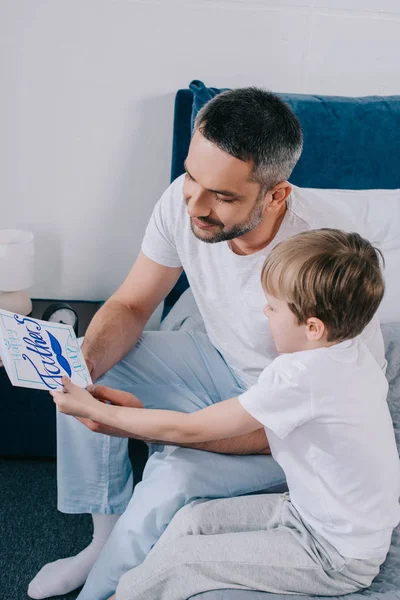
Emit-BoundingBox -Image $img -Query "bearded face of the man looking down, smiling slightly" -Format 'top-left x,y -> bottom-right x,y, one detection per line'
183,131 -> 265,243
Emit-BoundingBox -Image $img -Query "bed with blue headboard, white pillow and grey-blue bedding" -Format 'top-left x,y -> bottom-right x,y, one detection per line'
161,81 -> 400,600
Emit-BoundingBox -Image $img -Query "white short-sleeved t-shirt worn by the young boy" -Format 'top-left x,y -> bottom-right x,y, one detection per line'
239,337 -> 400,559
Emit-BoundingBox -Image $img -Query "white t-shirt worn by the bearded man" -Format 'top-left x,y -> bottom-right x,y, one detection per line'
142,175 -> 386,386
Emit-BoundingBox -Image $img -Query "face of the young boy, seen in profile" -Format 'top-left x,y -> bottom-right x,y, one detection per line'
264,294 -> 308,354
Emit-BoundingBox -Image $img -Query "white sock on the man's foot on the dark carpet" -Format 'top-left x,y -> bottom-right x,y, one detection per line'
28,514 -> 121,600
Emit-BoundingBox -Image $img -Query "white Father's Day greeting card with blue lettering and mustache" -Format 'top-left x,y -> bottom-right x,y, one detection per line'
0,310 -> 92,391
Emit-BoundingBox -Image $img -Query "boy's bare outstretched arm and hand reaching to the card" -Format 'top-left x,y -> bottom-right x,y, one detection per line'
52,380 -> 261,444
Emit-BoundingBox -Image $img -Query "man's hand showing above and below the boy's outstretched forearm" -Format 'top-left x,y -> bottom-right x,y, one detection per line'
75,385 -> 147,441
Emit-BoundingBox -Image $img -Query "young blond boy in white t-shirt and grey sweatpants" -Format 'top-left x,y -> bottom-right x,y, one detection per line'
52,229 -> 400,600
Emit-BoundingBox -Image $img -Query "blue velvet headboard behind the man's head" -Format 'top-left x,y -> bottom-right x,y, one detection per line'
165,81 -> 400,312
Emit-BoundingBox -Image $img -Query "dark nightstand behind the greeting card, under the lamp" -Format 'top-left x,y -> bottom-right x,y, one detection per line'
0,300 -> 102,457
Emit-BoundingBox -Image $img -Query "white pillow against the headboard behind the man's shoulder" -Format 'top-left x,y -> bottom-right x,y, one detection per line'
302,188 -> 400,323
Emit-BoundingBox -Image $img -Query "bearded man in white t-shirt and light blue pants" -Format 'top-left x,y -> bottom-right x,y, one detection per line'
28,88 -> 384,600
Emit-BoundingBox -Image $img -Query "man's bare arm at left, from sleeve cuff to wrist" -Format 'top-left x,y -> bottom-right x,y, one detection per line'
82,252 -> 182,381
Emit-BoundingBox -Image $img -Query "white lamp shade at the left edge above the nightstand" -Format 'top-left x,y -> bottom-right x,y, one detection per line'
0,229 -> 35,292
